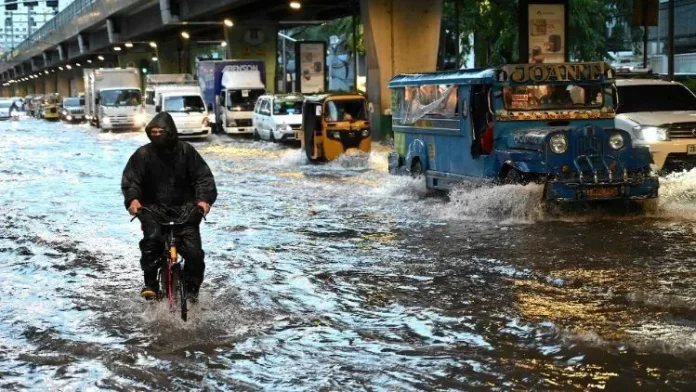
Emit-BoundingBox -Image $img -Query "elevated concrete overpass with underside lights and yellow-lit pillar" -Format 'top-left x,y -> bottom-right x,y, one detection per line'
0,0 -> 442,135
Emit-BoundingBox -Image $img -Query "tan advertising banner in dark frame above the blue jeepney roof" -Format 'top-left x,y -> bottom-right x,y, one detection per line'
527,4 -> 567,64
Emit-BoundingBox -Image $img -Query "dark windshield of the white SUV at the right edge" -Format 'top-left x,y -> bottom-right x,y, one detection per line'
617,84 -> 696,113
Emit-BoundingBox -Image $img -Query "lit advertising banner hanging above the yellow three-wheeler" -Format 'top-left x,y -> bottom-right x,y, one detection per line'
296,42 -> 326,94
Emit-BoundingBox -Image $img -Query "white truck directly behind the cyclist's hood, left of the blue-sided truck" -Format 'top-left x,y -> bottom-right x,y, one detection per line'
145,74 -> 210,139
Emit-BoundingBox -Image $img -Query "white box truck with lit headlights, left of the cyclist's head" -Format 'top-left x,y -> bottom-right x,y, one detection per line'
83,68 -> 146,130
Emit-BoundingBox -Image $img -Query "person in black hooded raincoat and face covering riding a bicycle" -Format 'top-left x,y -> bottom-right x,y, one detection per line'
121,112 -> 217,300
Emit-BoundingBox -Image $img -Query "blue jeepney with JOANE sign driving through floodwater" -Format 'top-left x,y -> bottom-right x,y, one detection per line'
389,63 -> 659,201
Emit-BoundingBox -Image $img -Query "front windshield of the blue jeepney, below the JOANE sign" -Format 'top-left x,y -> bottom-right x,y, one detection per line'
503,84 -> 604,110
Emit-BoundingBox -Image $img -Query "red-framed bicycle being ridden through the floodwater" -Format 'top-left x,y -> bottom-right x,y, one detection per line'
131,207 -> 205,321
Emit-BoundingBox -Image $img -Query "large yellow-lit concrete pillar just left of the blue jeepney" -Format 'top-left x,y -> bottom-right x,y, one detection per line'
360,0 -> 442,139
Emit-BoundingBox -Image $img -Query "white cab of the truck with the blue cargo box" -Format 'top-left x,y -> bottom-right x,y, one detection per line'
216,66 -> 266,134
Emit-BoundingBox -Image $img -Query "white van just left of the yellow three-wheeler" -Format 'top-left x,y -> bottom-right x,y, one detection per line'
252,94 -> 304,142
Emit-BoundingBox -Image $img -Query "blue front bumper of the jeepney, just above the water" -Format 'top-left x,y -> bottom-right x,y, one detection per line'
545,177 -> 659,201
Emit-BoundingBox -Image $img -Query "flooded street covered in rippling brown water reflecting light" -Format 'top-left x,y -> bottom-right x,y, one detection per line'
0,119 -> 696,391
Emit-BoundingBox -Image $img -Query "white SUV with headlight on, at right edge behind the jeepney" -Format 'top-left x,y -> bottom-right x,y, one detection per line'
616,79 -> 696,173
